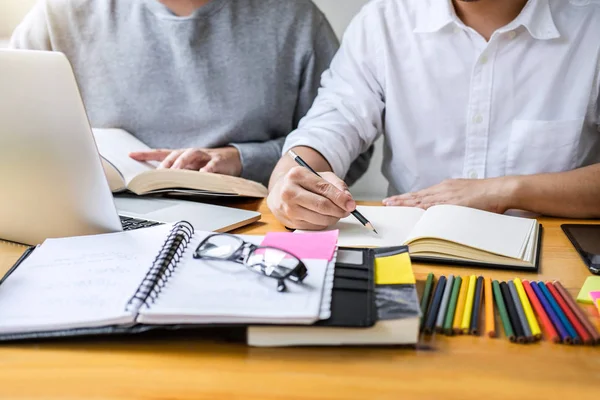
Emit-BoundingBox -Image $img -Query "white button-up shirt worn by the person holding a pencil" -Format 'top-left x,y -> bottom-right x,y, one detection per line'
284,0 -> 600,194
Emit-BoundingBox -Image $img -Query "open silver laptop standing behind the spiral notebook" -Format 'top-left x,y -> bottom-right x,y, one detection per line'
0,50 -> 260,244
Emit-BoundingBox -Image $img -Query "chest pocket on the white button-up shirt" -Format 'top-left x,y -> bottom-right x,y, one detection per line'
506,118 -> 584,175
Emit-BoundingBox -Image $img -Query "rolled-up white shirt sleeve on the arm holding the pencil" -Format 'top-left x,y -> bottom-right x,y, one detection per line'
283,7 -> 385,177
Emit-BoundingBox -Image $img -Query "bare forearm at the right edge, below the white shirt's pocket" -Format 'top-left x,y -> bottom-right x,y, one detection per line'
506,164 -> 600,218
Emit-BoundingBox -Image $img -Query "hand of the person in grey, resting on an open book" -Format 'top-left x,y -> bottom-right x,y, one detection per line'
129,146 -> 242,176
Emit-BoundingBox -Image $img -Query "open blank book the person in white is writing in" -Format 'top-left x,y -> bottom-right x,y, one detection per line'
310,205 -> 541,271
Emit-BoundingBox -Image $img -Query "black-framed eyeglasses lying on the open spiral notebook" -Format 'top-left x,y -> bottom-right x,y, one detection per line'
194,233 -> 308,292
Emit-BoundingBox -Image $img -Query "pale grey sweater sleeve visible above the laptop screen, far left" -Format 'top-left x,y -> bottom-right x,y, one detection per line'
10,1 -> 52,51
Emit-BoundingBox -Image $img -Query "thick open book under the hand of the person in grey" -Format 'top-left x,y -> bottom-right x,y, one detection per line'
93,129 -> 267,198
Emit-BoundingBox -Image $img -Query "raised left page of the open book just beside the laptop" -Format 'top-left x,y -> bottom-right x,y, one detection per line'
93,129 -> 157,185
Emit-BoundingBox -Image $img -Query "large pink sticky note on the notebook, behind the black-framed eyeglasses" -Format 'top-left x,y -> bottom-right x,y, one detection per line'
261,230 -> 340,261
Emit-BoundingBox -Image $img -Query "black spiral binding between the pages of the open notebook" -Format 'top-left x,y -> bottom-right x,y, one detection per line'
126,221 -> 194,311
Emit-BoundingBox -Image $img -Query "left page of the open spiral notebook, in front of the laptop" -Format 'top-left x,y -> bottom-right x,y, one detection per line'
0,225 -> 171,333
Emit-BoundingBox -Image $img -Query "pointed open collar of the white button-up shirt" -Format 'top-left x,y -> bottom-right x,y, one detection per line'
413,0 -> 560,40
